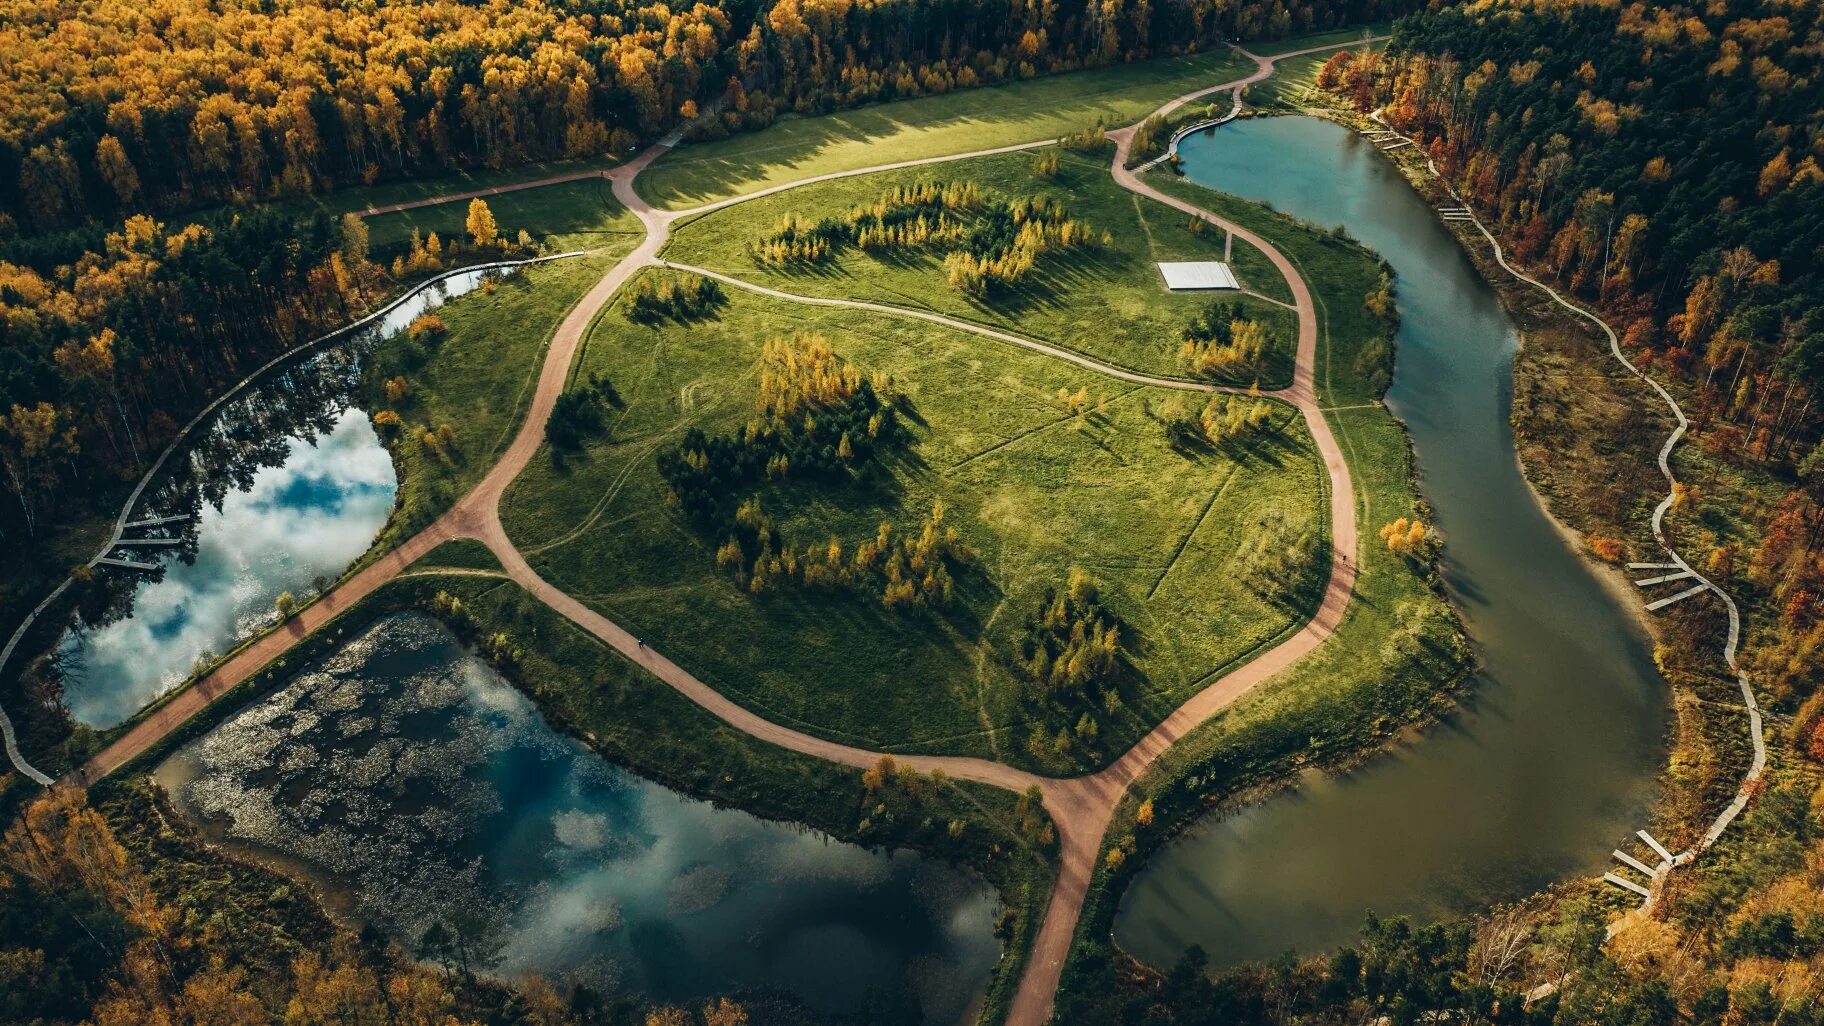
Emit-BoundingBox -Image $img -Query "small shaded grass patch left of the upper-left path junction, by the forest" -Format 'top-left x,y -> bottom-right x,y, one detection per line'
355,179 -> 642,256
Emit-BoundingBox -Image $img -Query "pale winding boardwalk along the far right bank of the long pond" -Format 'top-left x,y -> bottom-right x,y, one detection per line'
1370,111 -> 1767,883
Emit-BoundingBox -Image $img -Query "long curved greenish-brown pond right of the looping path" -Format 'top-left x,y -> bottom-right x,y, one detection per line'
1114,117 -> 1669,966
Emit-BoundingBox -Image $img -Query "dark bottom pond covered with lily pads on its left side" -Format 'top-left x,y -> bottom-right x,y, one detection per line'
157,613 -> 1001,1024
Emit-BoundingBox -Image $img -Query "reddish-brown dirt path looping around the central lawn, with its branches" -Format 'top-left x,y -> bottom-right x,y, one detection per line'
60,40 -> 1359,1026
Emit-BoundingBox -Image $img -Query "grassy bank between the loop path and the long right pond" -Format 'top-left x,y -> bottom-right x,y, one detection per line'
1058,173 -> 1468,1021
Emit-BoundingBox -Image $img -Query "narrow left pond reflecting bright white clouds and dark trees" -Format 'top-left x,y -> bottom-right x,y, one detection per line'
58,270 -> 502,728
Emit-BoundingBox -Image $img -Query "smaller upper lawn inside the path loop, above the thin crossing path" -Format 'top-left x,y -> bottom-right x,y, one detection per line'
664,153 -> 1297,389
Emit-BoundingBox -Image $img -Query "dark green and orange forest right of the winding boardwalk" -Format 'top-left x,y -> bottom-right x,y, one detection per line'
1357,0 -> 1824,711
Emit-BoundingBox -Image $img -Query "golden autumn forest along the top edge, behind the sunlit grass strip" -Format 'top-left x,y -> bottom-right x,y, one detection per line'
0,0 -> 1414,230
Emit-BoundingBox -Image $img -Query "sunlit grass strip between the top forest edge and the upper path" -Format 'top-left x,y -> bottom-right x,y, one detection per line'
638,47 -> 1253,208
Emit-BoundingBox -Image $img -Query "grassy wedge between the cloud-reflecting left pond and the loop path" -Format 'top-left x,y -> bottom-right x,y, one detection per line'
361,243 -> 631,551
